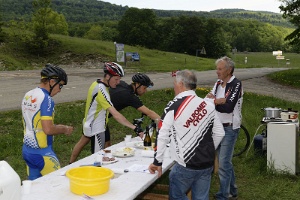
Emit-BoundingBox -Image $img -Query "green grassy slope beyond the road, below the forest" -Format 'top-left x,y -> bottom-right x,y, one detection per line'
0,28 -> 300,72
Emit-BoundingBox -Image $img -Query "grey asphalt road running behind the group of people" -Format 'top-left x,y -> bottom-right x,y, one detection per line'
0,68 -> 286,111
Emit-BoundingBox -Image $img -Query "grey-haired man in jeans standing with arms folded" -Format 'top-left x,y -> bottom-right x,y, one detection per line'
207,56 -> 243,200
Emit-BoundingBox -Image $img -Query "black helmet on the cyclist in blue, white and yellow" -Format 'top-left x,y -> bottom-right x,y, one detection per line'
41,63 -> 68,85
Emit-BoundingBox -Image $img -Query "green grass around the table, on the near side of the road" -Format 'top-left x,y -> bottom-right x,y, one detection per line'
0,88 -> 300,200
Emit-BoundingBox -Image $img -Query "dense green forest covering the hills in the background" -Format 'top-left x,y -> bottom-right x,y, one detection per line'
0,0 -> 299,57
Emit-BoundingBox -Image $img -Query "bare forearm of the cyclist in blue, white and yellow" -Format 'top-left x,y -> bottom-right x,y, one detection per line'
42,120 -> 73,135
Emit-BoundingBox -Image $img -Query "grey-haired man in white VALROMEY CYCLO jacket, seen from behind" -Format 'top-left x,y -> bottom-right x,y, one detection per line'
149,70 -> 225,200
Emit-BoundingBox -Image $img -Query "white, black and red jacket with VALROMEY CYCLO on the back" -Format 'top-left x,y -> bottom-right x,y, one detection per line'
154,90 -> 224,169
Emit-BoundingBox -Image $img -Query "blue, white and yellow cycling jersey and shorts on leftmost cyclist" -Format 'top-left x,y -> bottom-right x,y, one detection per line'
21,88 -> 60,180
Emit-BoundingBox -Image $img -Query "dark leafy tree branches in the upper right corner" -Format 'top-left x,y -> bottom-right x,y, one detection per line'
279,0 -> 300,49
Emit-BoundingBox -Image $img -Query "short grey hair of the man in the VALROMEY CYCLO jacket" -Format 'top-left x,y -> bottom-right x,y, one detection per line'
176,69 -> 197,90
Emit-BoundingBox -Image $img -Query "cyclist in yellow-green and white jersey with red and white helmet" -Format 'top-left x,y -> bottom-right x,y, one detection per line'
70,62 -> 143,163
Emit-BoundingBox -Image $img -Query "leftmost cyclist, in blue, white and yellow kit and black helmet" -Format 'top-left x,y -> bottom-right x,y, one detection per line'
21,64 -> 73,180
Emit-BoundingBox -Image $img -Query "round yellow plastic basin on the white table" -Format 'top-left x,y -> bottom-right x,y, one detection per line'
66,166 -> 114,196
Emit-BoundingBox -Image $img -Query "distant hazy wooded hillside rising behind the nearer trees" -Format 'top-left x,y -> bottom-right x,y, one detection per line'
0,0 -> 292,27
